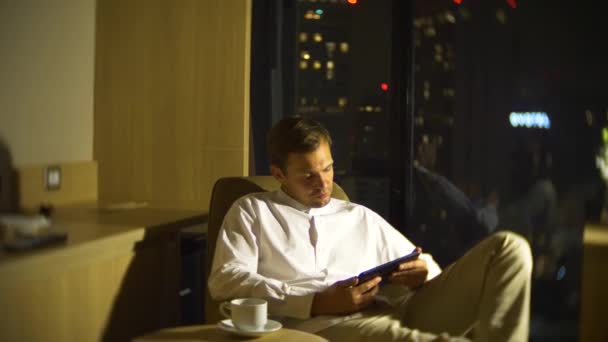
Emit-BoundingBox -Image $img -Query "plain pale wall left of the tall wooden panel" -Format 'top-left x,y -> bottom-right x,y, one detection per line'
0,0 -> 95,166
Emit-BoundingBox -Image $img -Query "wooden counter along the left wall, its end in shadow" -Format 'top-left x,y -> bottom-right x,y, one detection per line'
0,205 -> 204,341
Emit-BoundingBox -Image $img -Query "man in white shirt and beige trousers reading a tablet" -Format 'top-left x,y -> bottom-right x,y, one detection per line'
209,117 -> 532,341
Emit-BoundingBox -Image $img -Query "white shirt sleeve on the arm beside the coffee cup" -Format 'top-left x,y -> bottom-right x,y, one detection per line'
208,200 -> 314,319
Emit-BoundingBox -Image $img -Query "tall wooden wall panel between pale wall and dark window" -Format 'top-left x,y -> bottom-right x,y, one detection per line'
94,0 -> 251,210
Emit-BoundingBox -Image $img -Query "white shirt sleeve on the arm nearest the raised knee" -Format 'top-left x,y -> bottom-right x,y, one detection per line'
373,213 -> 441,281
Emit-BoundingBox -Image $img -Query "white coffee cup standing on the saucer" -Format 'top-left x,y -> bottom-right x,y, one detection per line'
220,298 -> 268,331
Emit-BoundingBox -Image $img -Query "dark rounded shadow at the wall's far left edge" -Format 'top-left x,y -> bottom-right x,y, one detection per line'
0,137 -> 19,213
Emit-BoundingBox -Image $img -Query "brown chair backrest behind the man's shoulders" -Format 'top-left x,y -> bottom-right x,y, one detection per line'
205,176 -> 348,323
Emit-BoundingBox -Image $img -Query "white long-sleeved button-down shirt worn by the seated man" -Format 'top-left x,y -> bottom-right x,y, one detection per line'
208,190 -> 441,331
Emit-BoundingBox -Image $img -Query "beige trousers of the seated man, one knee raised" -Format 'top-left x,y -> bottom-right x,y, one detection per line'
317,232 -> 532,342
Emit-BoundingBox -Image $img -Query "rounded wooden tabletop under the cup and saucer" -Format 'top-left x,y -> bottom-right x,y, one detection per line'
133,324 -> 327,342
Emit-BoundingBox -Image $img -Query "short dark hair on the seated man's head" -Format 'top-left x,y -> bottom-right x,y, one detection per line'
268,116 -> 331,171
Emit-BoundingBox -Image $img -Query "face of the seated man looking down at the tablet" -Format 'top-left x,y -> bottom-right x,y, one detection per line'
271,141 -> 334,208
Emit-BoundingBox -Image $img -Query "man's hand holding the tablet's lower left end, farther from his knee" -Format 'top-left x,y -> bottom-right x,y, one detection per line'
310,277 -> 382,315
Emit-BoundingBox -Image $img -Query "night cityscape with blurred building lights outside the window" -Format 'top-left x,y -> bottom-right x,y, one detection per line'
252,0 -> 608,341
